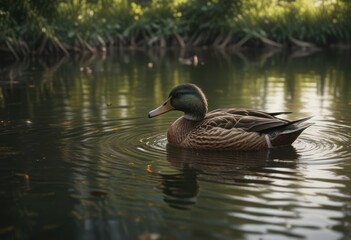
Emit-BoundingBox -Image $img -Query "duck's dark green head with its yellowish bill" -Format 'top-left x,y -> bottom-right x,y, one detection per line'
149,83 -> 207,121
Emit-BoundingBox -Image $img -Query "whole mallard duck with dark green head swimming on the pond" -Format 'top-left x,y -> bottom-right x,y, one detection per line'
148,83 -> 312,150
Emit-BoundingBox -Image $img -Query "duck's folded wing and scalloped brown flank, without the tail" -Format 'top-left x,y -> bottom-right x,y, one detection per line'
183,111 -> 274,150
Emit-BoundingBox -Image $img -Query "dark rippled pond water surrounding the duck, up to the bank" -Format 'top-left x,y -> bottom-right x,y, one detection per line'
0,50 -> 351,239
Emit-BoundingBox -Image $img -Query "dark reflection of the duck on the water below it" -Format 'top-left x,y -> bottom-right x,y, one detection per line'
160,145 -> 299,209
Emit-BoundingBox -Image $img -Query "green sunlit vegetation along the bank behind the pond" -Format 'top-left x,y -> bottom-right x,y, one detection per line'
0,0 -> 351,58
